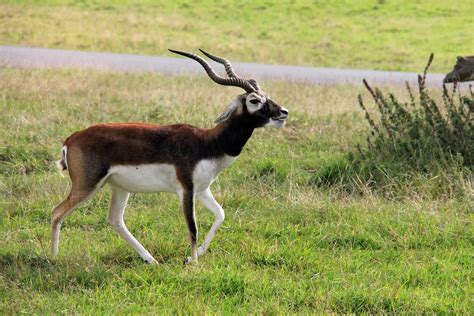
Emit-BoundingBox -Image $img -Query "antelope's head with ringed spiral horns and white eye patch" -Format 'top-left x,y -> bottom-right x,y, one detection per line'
170,49 -> 288,128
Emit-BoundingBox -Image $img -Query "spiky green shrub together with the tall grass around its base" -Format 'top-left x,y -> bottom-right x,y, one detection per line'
311,54 -> 474,198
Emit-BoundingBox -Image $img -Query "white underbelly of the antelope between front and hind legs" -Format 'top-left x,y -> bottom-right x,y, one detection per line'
107,164 -> 182,193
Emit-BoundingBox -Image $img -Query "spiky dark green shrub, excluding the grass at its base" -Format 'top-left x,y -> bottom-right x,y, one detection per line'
358,54 -> 474,172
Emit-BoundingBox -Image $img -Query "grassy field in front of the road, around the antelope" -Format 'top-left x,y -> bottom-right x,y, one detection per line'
0,69 -> 474,315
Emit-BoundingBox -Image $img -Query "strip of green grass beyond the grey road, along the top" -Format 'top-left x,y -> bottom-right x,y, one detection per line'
0,0 -> 474,72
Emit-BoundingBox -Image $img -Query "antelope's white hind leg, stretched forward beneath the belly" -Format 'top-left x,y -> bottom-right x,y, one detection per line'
108,186 -> 158,263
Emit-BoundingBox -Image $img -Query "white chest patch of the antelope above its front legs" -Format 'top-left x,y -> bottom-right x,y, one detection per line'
193,155 -> 236,192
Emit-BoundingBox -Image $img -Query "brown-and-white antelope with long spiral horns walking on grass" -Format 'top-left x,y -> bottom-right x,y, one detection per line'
51,50 -> 288,263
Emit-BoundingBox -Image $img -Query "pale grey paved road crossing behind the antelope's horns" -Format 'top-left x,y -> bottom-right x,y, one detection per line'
0,46 -> 452,86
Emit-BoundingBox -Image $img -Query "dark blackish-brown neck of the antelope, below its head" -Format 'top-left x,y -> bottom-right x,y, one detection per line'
208,118 -> 255,157
